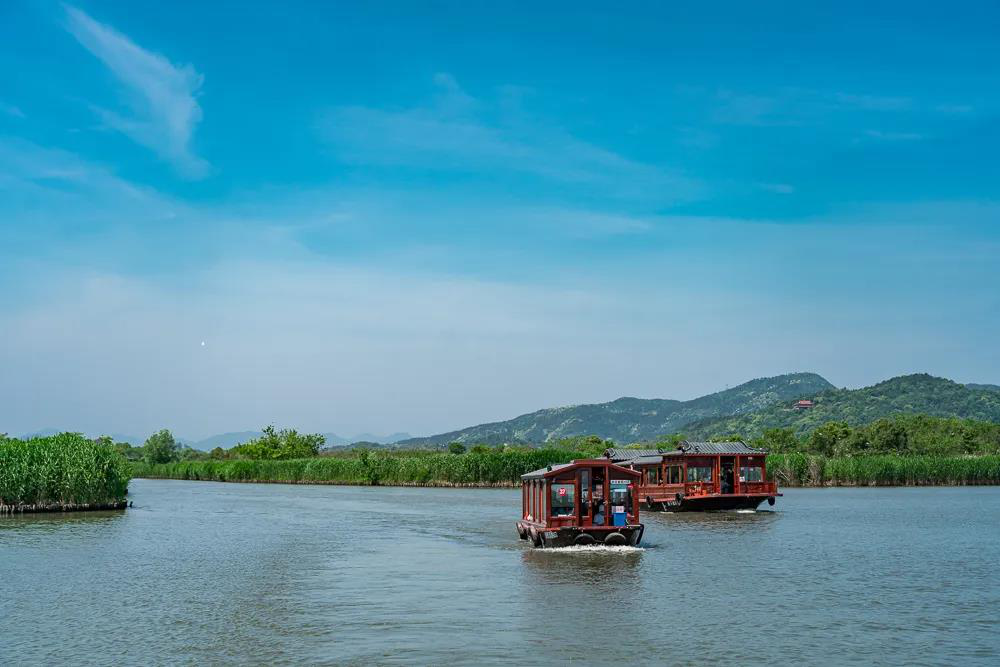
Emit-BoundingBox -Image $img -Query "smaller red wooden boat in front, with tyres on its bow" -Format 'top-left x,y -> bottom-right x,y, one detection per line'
517,458 -> 643,547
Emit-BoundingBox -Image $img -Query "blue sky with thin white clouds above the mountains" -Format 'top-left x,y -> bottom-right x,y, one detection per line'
0,2 -> 1000,437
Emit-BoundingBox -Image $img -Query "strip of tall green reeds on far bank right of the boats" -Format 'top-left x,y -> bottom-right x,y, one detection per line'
767,454 -> 1000,486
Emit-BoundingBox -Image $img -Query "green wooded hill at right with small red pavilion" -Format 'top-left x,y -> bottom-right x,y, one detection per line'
684,373 -> 1000,439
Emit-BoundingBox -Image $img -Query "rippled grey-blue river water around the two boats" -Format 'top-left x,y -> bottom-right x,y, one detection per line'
0,480 -> 1000,665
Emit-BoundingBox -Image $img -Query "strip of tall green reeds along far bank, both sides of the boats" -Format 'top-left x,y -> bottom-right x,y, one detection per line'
134,449 -> 1000,487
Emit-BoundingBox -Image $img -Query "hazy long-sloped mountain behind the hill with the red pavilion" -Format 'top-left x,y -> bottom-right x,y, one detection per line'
397,373 -> 833,447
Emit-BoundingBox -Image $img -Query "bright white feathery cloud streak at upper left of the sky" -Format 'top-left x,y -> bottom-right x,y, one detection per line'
66,6 -> 208,178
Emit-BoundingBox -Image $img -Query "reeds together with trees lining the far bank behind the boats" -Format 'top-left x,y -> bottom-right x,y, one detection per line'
129,415 -> 1000,486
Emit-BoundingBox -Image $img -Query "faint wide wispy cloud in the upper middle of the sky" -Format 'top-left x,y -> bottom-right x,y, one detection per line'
321,74 -> 701,201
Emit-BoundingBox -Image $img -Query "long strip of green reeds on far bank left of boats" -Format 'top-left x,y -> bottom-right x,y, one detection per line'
134,449 -> 587,486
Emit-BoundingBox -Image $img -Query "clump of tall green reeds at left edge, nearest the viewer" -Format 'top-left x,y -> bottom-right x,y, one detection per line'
0,433 -> 132,507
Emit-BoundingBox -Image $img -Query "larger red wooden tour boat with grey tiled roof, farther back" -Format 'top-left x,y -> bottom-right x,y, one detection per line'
604,441 -> 781,512
